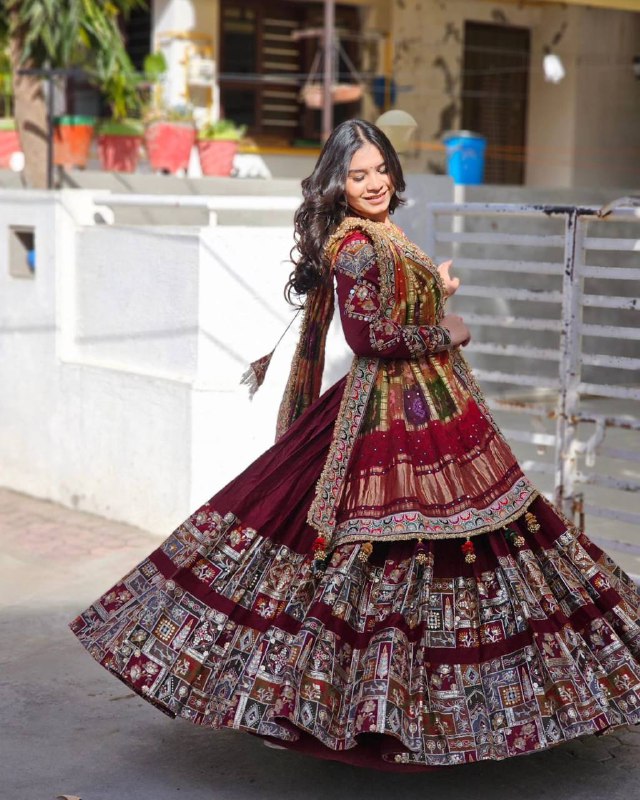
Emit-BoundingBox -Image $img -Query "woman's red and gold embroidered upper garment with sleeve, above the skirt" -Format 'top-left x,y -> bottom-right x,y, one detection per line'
308,219 -> 536,547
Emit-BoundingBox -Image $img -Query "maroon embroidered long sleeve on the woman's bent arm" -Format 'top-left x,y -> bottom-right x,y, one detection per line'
335,232 -> 451,358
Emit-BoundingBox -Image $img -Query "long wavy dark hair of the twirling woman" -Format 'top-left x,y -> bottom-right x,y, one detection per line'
284,119 -> 405,305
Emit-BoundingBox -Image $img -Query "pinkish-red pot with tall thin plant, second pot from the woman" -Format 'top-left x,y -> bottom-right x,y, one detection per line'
144,52 -> 196,172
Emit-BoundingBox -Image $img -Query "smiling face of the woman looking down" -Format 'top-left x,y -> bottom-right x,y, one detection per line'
345,142 -> 393,222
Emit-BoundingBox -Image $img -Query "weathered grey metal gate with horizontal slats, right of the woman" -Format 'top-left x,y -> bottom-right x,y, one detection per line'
427,198 -> 640,574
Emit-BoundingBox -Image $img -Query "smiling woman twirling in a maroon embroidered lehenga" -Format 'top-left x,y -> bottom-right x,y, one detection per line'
72,120 -> 640,771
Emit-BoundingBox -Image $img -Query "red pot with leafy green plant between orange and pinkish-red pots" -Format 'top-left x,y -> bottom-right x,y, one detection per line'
98,64 -> 144,172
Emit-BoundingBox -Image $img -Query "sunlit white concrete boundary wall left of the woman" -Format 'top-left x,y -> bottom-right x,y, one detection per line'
0,191 -> 310,532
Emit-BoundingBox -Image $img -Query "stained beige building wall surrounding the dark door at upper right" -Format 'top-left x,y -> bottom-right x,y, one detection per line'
393,0 -> 640,187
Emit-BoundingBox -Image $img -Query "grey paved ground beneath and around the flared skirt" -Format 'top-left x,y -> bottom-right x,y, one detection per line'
0,489 -> 640,800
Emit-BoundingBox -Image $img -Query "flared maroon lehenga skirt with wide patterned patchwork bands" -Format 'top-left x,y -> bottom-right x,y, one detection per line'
71,381 -> 640,771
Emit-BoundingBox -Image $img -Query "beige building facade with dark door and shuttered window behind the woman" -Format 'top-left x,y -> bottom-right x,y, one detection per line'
130,0 -> 640,187
